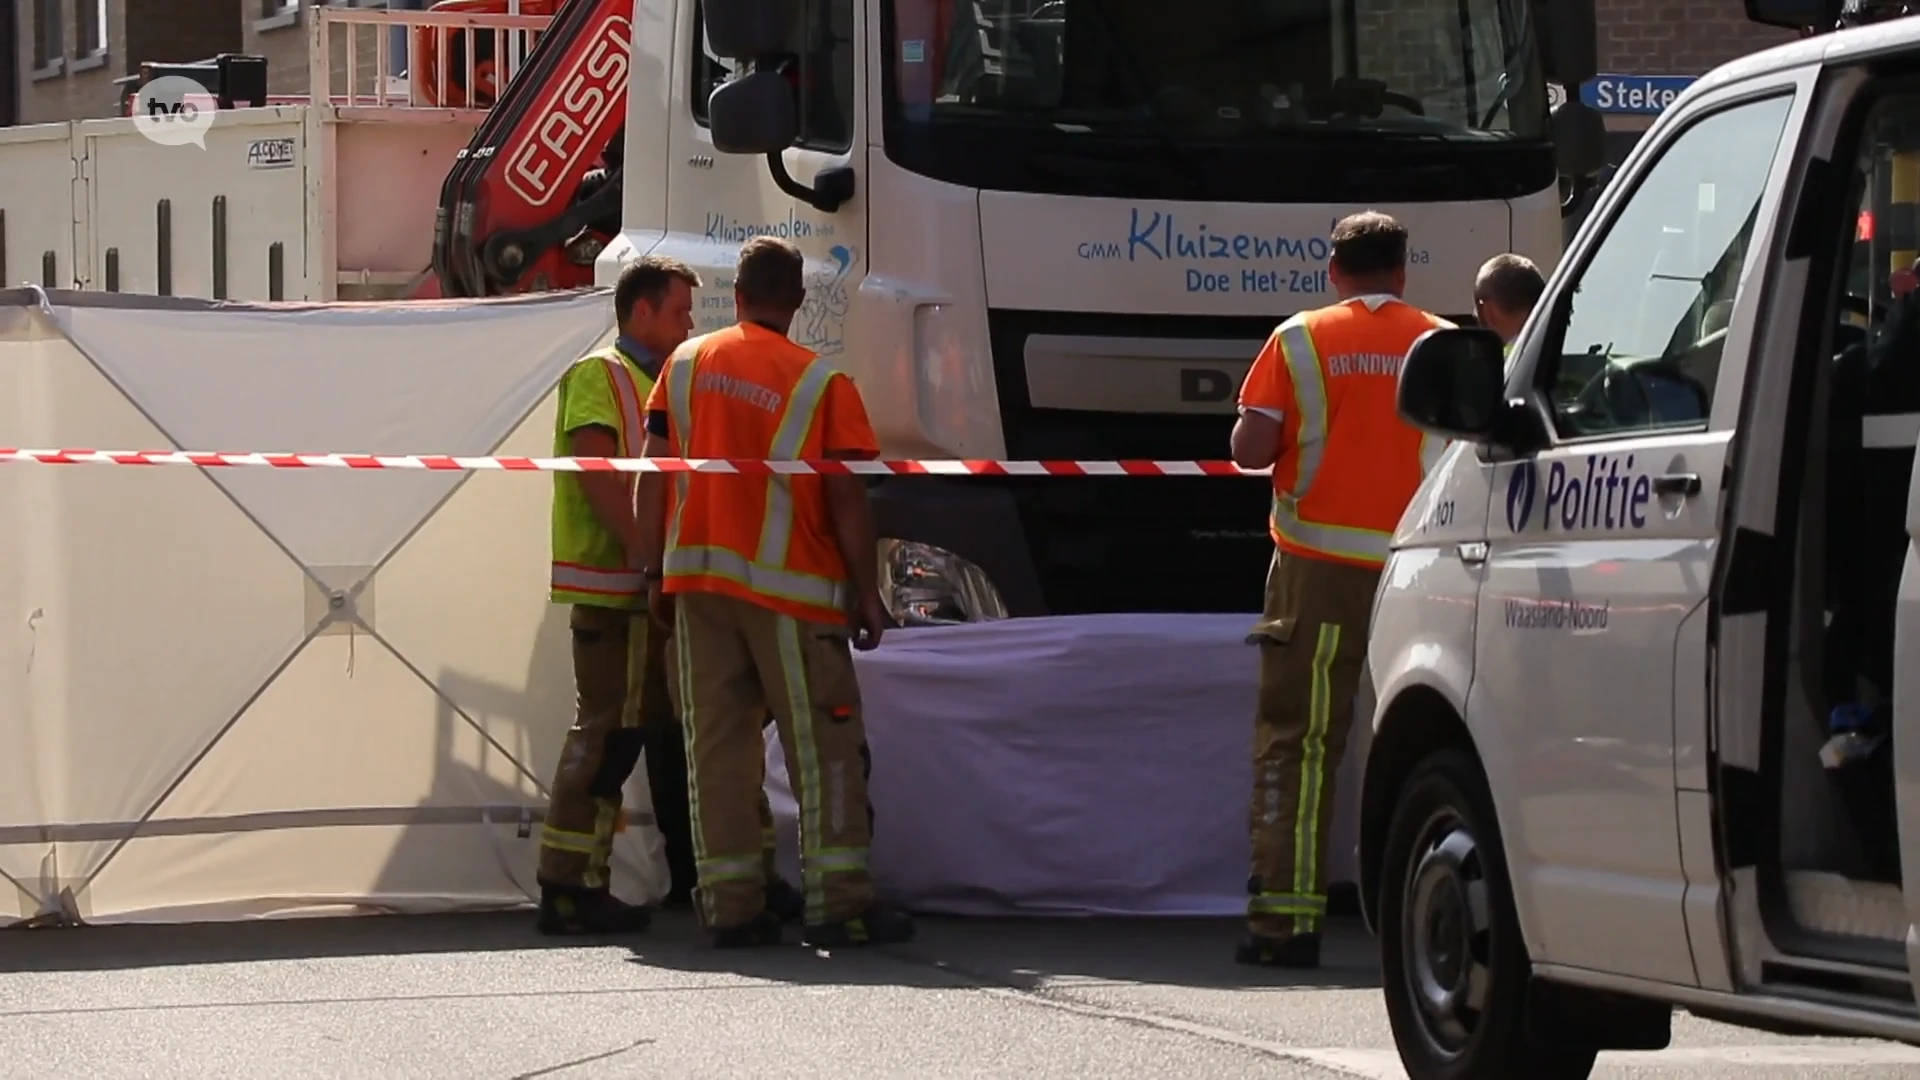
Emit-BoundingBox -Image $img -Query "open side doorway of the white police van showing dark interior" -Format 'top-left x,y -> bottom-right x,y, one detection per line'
1712,65 -> 1920,1011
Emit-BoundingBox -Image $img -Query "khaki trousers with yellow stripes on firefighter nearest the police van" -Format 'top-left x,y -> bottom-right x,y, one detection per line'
1246,552 -> 1380,938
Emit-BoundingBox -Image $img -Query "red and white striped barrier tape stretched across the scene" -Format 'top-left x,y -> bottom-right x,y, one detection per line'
0,446 -> 1265,477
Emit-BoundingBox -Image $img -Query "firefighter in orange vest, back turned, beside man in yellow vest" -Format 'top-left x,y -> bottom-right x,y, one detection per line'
622,236 -> 914,947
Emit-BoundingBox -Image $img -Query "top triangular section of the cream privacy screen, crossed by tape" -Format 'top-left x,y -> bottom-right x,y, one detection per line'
60,304 -> 609,567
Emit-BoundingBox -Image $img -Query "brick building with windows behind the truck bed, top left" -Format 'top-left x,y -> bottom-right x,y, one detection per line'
0,0 -> 416,125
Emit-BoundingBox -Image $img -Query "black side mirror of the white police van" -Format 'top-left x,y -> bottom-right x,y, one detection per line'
1398,327 -> 1507,442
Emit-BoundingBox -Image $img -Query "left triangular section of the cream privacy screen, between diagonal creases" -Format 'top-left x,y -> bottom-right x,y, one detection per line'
0,311 -> 305,890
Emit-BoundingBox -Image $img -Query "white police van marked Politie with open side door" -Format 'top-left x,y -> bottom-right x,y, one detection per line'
1359,4 -> 1920,1080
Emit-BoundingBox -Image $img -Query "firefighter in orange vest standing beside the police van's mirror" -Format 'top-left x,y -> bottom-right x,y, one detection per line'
1233,211 -> 1450,967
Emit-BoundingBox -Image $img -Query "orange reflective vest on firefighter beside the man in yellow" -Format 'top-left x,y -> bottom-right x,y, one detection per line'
647,323 -> 879,623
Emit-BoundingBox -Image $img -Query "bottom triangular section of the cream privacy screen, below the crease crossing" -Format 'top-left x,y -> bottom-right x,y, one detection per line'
83,634 -> 543,915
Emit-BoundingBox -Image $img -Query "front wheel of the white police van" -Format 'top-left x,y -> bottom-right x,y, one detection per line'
1379,749 -> 1597,1080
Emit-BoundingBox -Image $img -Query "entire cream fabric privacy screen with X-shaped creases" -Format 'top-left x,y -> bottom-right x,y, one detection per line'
0,290 -> 666,922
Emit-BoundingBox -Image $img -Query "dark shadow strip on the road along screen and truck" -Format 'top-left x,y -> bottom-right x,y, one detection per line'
0,899 -> 1379,990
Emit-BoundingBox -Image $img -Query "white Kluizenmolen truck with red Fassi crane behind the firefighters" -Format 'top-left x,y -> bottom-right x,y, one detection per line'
0,0 -> 1601,621
